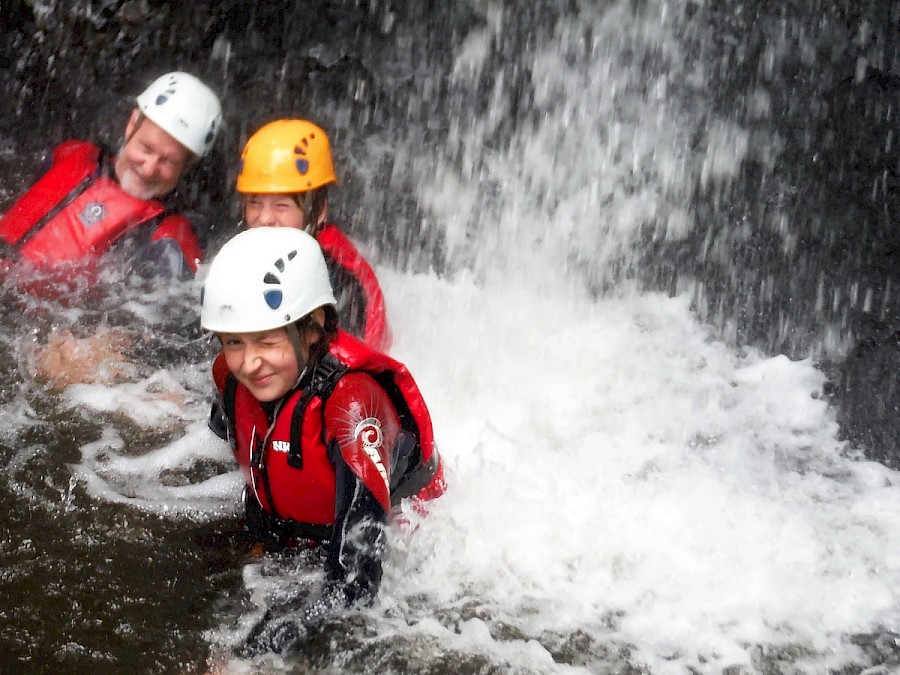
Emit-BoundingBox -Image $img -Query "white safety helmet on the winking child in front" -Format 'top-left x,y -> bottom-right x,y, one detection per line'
200,227 -> 335,333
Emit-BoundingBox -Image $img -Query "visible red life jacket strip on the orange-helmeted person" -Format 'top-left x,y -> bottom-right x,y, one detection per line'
316,223 -> 392,351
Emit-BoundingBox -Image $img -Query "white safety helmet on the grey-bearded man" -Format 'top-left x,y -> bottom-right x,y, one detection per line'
137,72 -> 222,157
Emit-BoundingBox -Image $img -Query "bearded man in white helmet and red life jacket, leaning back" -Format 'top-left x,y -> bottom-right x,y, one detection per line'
0,72 -> 222,276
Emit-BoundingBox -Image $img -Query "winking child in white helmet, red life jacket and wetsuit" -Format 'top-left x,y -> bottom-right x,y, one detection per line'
200,227 -> 444,653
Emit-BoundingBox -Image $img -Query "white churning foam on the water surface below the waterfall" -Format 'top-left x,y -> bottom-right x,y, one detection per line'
67,269 -> 900,673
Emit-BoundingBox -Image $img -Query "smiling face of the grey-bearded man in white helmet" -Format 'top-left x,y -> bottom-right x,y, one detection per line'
115,110 -> 193,199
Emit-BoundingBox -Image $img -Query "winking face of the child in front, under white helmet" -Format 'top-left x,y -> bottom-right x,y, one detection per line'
219,328 -> 306,403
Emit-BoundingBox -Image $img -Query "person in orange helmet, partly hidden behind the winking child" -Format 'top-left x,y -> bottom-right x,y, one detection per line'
237,119 -> 391,351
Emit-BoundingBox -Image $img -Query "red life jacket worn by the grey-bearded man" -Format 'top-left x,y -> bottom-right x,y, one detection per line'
0,141 -> 202,272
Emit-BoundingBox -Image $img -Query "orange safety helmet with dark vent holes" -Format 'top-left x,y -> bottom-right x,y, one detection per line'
237,120 -> 337,194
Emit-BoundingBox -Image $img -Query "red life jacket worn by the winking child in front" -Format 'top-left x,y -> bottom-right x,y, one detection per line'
213,330 -> 445,526
